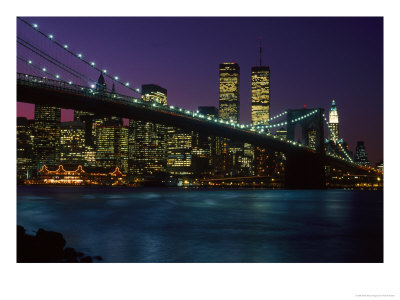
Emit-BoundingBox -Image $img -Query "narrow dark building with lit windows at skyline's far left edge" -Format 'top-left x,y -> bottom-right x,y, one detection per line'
17,117 -> 33,182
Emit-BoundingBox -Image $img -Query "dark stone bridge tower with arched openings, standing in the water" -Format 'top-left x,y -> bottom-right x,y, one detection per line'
285,108 -> 325,189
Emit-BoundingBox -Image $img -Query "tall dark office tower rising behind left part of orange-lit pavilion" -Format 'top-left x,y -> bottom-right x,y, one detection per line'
33,105 -> 61,171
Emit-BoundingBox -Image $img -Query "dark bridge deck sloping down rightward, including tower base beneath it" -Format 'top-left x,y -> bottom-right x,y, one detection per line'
17,73 -> 368,188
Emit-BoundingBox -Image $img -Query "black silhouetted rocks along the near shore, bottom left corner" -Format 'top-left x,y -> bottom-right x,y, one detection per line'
17,225 -> 102,263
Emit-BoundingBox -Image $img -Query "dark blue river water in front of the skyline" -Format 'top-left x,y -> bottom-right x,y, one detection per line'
17,186 -> 383,263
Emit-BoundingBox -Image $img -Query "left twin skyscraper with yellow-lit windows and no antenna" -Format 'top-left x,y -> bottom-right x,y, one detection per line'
219,63 -> 240,123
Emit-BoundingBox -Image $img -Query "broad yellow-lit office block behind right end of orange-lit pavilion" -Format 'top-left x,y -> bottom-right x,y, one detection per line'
95,120 -> 128,171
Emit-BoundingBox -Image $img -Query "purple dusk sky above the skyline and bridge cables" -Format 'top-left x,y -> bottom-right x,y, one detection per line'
17,17 -> 383,163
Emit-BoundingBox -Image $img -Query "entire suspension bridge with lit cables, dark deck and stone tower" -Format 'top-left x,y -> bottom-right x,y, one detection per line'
17,18 -> 378,188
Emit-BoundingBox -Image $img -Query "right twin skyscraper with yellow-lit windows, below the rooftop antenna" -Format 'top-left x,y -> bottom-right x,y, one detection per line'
251,66 -> 270,124
